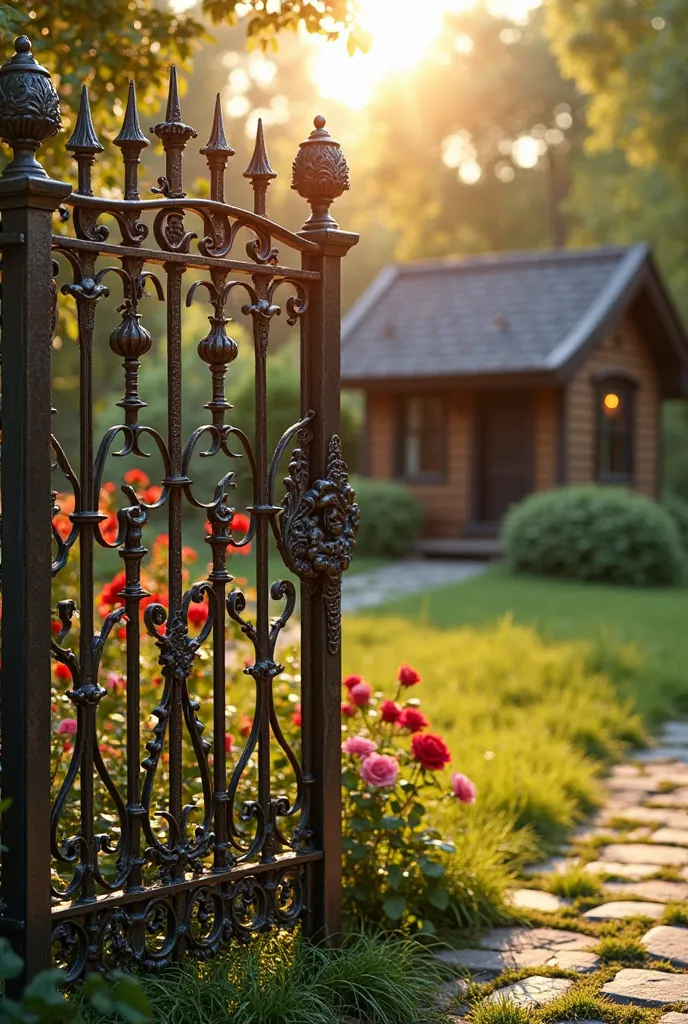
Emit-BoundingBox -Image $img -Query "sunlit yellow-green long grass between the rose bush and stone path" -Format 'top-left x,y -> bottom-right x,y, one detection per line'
344,616 -> 644,929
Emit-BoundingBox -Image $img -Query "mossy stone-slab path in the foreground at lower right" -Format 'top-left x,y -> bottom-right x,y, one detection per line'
437,722 -> 688,1024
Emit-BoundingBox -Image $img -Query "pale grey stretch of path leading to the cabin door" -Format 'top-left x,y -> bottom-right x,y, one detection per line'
342,558 -> 483,610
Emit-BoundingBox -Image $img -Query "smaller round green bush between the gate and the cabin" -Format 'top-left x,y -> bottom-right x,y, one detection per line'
351,476 -> 423,558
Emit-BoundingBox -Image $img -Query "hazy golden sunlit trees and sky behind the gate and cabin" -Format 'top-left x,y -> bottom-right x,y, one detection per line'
0,0 -> 688,497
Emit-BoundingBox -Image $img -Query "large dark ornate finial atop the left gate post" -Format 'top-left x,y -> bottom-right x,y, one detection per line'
0,36 -> 62,178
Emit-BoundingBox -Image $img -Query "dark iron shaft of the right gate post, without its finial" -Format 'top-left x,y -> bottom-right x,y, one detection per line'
301,228 -> 357,938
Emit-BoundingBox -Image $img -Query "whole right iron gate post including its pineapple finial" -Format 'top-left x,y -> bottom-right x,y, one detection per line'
292,117 -> 358,940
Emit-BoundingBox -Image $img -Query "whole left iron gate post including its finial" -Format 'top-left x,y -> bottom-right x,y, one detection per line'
0,37 -> 72,991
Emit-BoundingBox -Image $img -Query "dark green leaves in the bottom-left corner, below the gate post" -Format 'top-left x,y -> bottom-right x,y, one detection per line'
0,938 -> 153,1024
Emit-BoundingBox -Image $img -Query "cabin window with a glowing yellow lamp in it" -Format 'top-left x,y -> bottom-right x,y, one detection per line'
595,377 -> 636,483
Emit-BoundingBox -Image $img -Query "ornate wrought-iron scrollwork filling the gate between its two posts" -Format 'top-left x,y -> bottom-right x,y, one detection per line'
50,228 -> 320,981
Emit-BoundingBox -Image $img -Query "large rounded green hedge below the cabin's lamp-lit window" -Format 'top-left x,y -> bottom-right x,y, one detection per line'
502,485 -> 685,587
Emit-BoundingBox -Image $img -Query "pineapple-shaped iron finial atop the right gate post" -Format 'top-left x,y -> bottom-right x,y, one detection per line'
292,114 -> 349,230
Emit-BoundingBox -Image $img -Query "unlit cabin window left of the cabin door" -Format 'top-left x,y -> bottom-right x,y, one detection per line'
397,395 -> 446,483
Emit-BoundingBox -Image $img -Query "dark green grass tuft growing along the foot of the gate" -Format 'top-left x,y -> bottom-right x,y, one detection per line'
105,935 -> 439,1024
